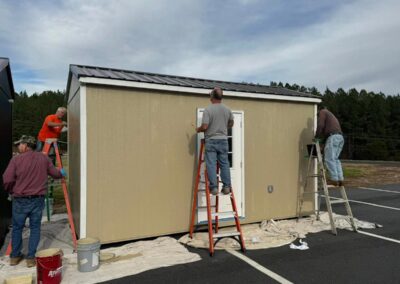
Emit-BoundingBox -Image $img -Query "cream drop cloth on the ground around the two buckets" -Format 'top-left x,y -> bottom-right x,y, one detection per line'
0,215 -> 201,283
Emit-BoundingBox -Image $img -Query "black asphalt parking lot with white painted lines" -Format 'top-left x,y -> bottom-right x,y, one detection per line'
107,184 -> 400,283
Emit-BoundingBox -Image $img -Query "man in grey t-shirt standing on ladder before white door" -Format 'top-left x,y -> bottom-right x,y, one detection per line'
196,88 -> 233,195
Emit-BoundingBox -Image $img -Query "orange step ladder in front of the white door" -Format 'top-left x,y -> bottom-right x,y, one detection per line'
189,139 -> 246,256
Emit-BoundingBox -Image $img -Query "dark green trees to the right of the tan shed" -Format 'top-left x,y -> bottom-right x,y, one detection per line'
271,82 -> 400,161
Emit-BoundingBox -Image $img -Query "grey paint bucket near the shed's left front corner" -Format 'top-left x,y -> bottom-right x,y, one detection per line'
77,238 -> 100,272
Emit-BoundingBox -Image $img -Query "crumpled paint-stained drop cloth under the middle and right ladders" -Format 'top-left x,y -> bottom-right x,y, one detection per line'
179,212 -> 376,249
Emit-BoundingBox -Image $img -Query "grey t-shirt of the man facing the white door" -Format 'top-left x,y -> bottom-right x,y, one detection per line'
202,103 -> 233,140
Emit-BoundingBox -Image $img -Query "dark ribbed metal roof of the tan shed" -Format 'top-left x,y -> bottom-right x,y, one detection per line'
67,64 -> 320,98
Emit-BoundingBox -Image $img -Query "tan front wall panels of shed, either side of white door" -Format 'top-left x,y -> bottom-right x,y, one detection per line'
85,86 -> 314,243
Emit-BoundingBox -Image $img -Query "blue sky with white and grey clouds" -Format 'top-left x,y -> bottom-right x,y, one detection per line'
0,0 -> 400,95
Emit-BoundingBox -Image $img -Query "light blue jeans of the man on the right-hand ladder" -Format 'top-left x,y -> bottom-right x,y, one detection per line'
324,134 -> 344,181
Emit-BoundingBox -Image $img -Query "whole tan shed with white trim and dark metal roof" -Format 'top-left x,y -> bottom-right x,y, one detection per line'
67,65 -> 320,243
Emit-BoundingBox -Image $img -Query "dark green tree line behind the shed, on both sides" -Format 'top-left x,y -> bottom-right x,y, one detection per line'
13,85 -> 400,161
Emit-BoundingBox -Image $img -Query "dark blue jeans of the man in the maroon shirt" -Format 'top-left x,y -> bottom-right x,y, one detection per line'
10,197 -> 44,258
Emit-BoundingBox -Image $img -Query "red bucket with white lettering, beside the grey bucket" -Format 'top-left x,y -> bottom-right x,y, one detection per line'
35,248 -> 63,284
